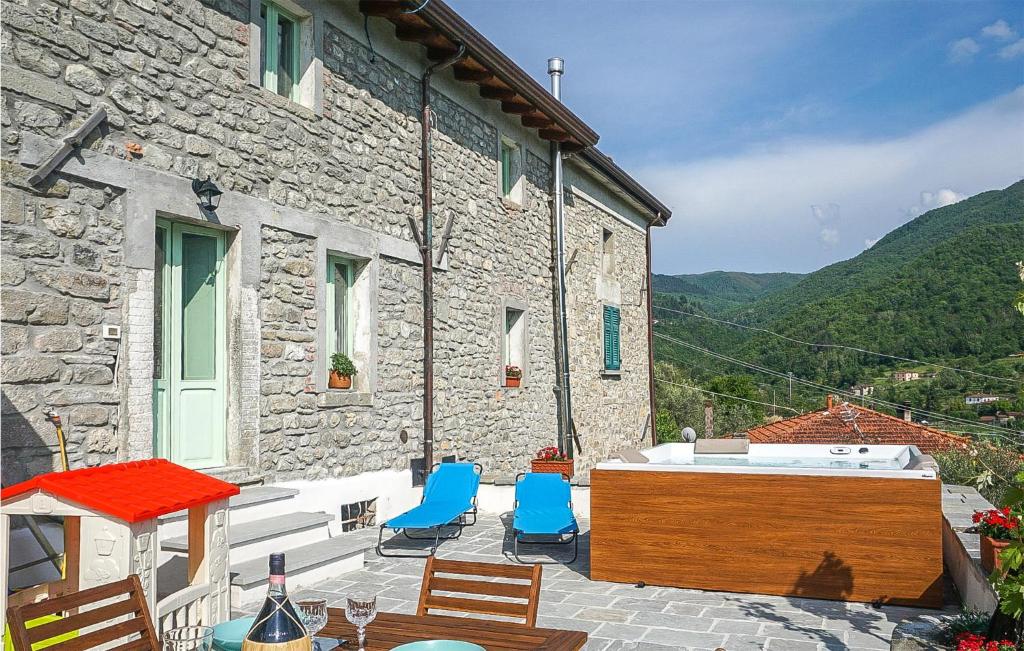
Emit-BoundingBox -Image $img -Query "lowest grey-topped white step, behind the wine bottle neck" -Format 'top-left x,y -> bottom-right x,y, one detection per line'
230,527 -> 377,608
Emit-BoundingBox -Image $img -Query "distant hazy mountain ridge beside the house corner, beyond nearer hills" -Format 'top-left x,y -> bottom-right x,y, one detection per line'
653,271 -> 804,312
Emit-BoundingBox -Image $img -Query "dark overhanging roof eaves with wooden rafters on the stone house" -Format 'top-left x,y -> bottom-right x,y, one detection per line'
359,0 -> 672,225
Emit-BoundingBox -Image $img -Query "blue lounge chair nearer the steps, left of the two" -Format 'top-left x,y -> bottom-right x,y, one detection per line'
377,464 -> 483,558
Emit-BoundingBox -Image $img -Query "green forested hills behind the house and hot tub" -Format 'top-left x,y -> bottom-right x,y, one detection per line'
654,182 -> 1024,448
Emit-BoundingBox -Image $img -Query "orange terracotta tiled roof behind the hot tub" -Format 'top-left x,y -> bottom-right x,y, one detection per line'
748,403 -> 970,453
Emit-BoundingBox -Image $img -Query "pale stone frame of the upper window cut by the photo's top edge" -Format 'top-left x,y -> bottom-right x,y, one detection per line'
249,0 -> 324,116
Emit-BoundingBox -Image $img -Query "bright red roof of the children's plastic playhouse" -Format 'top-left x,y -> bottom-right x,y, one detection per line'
0,459 -> 239,522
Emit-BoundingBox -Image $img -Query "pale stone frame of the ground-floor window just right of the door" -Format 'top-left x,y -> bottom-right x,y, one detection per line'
313,243 -> 380,401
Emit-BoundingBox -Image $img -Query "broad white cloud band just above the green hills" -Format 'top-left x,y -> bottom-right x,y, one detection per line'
637,86 -> 1024,273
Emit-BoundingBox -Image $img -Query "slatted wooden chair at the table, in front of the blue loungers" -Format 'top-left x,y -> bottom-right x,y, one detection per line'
416,556 -> 542,626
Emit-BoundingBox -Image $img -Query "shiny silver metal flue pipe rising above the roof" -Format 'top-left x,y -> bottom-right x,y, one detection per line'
548,56 -> 573,459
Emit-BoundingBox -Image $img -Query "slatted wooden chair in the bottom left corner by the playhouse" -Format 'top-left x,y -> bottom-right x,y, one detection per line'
7,574 -> 160,651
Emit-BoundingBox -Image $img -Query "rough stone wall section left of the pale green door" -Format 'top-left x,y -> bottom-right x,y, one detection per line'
0,165 -> 124,484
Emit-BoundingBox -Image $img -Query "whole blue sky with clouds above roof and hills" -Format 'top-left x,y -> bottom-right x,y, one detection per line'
449,0 -> 1024,273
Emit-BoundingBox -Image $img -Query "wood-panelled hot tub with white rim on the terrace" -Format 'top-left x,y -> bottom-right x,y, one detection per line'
590,442 -> 942,607
